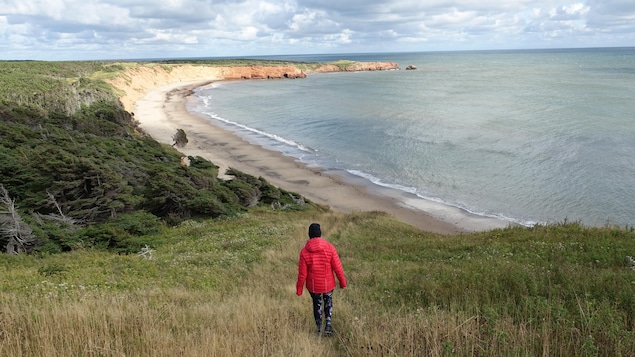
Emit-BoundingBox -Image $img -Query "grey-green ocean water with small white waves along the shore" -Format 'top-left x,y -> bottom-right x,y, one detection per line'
188,48 -> 635,227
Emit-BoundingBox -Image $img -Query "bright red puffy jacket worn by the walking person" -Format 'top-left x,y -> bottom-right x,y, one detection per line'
295,237 -> 346,296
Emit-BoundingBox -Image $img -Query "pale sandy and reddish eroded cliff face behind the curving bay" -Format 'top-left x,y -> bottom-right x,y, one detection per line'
106,62 -> 399,112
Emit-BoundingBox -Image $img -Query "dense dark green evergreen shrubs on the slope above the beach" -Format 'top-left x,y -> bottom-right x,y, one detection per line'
0,62 -> 314,252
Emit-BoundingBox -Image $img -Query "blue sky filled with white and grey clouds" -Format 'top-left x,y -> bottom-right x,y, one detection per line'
0,0 -> 635,60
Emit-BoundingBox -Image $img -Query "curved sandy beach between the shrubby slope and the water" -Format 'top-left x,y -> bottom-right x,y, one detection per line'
134,81 -> 508,234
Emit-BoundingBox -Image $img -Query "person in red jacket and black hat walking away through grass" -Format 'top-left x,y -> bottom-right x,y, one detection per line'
296,223 -> 346,336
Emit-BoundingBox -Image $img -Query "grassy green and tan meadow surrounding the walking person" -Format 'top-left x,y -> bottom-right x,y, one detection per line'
0,209 -> 635,356
